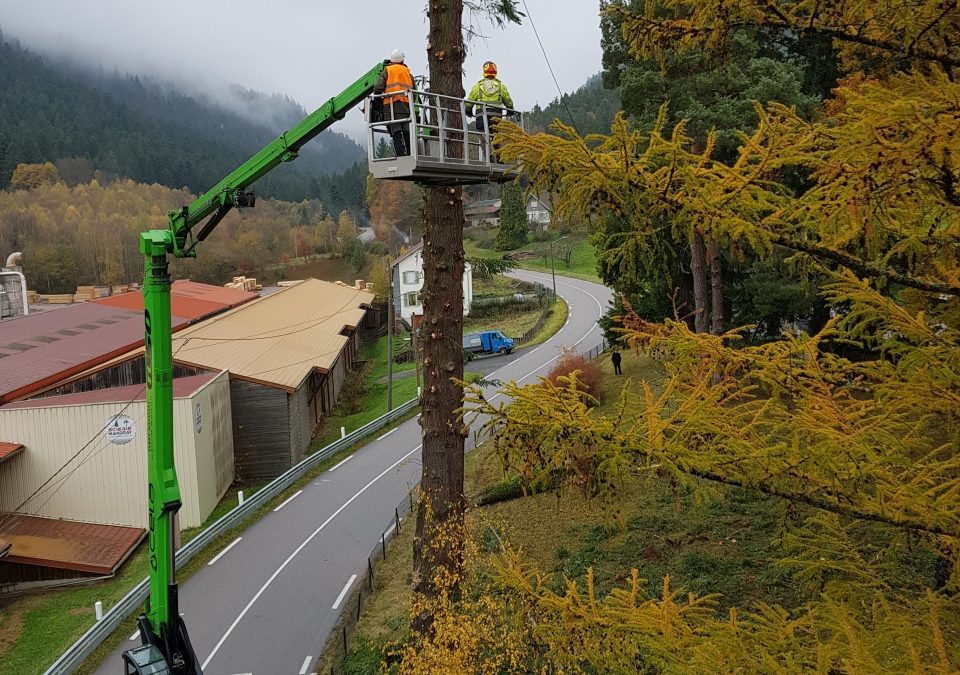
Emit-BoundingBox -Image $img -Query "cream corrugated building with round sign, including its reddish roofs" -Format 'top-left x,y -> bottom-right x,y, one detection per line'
0,372 -> 233,590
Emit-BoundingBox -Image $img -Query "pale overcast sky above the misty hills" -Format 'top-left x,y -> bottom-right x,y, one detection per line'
0,0 -> 600,138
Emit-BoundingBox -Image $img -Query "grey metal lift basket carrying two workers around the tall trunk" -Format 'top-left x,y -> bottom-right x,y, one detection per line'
364,89 -> 523,185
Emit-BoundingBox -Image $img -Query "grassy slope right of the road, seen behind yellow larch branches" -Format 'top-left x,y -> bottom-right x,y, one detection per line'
345,353 -> 804,672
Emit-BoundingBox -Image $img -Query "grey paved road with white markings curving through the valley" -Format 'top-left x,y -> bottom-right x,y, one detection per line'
96,271 -> 611,675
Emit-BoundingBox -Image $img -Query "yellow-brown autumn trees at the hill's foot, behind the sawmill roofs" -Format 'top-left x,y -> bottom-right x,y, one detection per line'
0,163 -> 382,293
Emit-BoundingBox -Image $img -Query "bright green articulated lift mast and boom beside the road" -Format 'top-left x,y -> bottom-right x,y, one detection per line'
124,64 -> 384,675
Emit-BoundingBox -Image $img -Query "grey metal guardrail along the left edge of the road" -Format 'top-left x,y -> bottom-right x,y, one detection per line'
45,398 -> 419,675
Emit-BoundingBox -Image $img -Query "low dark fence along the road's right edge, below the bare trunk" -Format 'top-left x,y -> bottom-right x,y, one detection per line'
326,488 -> 416,675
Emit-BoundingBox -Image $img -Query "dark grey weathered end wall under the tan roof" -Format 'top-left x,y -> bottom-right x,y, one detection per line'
230,379 -> 290,481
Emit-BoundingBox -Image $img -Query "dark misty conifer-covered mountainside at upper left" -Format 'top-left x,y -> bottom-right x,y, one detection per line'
0,33 -> 366,209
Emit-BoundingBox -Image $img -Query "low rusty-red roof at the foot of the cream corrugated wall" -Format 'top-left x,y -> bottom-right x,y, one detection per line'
0,513 -> 147,574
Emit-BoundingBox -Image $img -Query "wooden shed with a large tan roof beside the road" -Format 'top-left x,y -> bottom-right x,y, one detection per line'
173,279 -> 374,481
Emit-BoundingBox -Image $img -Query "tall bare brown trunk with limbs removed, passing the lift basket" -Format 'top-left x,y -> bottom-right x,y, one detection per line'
413,0 -> 465,634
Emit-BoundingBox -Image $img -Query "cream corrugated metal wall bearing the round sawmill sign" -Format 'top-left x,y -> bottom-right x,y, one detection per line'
0,373 -> 230,528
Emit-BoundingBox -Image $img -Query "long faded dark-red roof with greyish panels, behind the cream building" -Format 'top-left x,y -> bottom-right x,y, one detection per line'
0,302 -> 190,405
